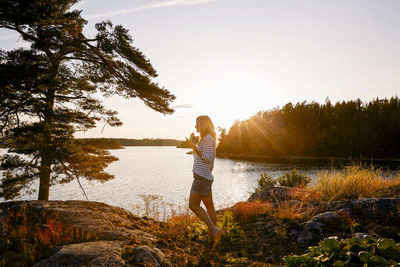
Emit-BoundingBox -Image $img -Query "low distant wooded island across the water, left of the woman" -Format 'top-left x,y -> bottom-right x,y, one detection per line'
79,138 -> 183,149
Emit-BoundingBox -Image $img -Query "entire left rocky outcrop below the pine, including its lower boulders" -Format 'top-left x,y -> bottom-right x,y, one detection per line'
0,201 -> 170,267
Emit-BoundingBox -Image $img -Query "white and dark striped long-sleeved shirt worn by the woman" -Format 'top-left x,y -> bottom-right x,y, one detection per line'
193,134 -> 216,180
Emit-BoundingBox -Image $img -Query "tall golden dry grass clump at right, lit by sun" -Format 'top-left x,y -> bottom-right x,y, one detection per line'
308,166 -> 400,201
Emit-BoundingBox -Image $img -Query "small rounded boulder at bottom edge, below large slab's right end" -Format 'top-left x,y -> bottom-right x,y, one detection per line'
131,246 -> 172,266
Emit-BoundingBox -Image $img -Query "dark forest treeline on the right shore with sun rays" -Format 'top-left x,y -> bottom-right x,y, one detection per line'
217,96 -> 400,159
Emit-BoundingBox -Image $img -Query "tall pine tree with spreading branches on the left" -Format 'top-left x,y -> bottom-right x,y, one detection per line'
0,0 -> 175,200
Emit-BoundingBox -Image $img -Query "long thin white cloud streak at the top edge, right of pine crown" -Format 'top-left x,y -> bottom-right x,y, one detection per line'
86,0 -> 221,19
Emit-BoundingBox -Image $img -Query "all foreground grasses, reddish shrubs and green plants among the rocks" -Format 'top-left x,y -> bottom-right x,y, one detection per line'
1,166 -> 400,266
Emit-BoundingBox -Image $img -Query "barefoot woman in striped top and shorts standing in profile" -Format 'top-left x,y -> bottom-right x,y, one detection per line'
186,116 -> 222,241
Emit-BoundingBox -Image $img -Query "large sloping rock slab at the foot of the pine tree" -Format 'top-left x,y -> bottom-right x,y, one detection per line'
0,200 -> 156,243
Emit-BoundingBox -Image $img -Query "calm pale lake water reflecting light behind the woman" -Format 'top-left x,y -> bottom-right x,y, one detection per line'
0,147 -> 324,214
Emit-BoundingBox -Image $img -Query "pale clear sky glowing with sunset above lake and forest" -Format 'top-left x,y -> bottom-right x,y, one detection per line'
0,0 -> 400,139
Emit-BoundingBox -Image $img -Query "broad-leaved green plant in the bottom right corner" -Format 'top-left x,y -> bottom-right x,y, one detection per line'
283,236 -> 400,267
